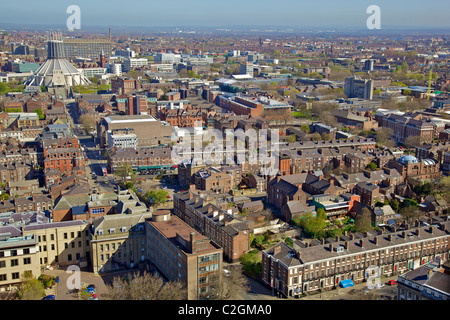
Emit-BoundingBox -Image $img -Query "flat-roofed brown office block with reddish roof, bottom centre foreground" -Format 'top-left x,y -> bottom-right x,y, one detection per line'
145,210 -> 223,300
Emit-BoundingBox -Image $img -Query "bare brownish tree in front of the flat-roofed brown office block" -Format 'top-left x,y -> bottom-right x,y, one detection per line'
106,272 -> 187,300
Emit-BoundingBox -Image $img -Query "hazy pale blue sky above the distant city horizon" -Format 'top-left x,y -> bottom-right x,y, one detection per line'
0,0 -> 450,28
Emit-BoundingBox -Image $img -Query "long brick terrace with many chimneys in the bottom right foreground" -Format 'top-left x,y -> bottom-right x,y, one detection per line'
261,218 -> 450,297
